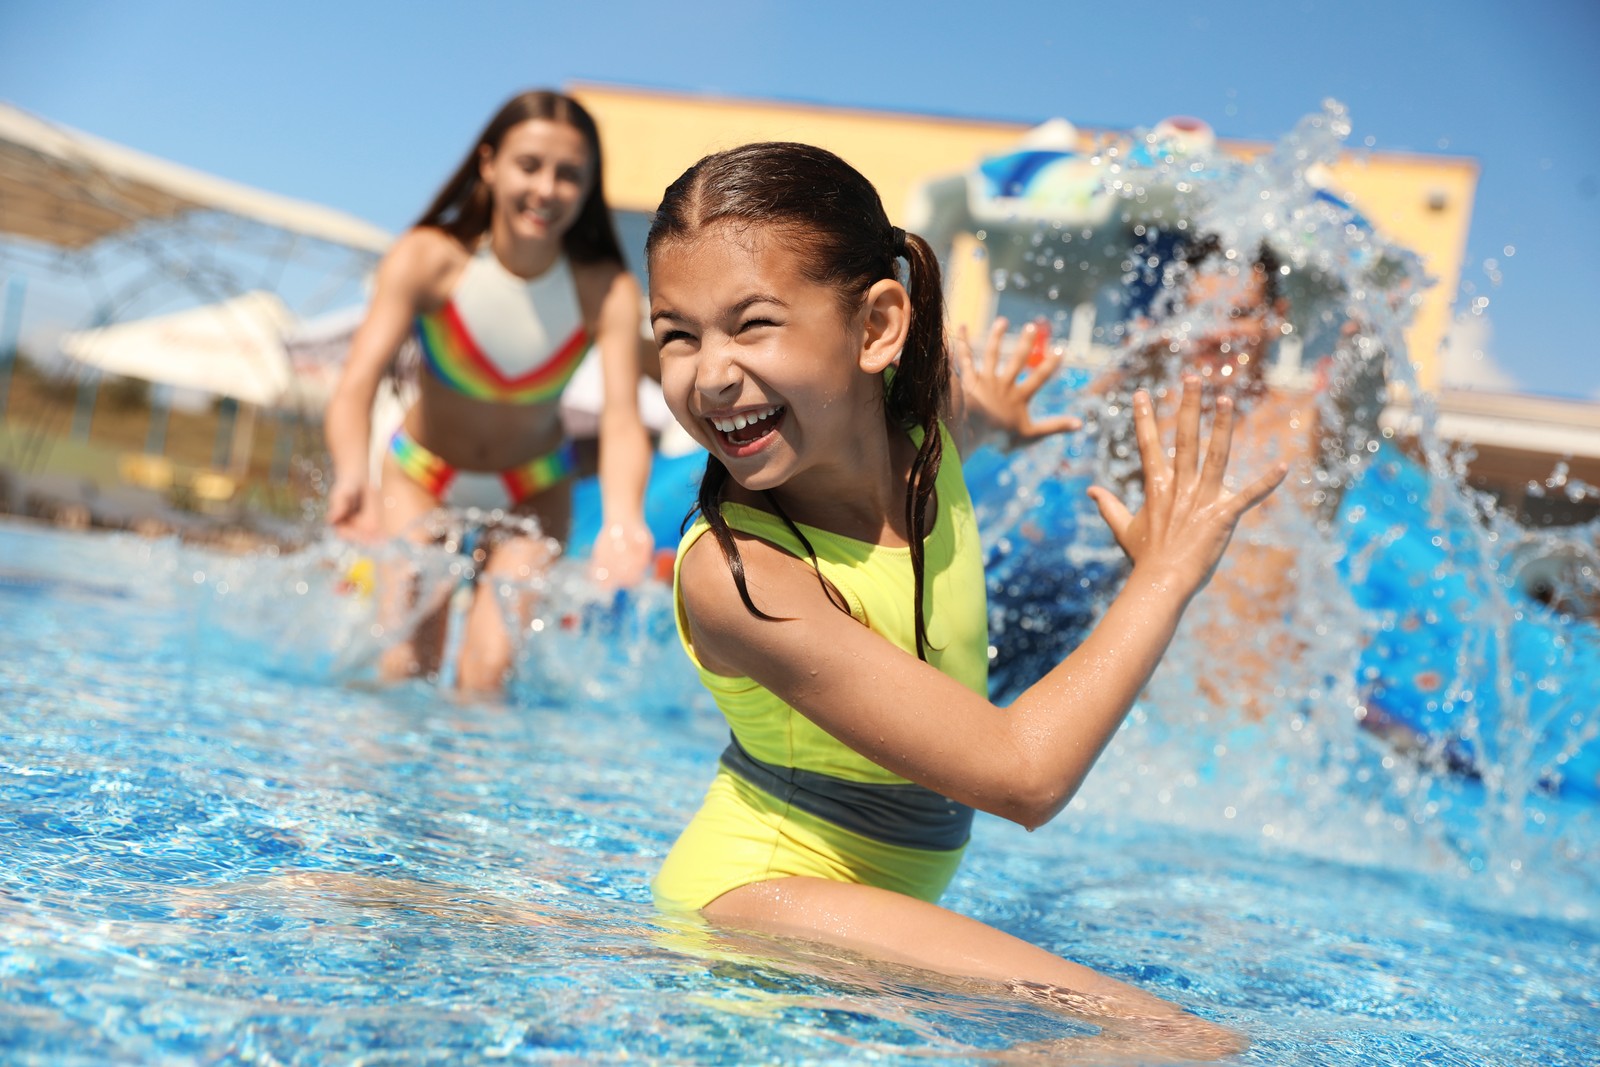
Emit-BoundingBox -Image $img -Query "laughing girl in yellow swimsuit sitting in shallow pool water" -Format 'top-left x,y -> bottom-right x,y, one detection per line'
648,144 -> 1283,1057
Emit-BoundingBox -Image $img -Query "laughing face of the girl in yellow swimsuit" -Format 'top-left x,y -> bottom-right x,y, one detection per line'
650,224 -> 883,490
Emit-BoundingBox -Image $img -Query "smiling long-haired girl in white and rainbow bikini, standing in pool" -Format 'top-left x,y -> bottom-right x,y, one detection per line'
325,90 -> 653,689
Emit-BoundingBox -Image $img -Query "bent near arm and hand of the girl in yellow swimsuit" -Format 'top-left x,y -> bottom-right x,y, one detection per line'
682,382 -> 1285,829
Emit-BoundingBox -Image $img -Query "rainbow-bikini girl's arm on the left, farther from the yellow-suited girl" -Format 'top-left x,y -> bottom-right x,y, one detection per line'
323,230 -> 453,539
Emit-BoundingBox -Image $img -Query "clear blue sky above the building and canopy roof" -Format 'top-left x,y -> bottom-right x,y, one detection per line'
0,0 -> 1600,397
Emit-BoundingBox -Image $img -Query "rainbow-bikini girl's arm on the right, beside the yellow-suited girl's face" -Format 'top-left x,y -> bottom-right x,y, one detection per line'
592,270 -> 656,585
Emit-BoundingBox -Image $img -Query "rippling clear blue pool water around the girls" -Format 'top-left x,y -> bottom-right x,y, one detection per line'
0,526 -> 1600,1065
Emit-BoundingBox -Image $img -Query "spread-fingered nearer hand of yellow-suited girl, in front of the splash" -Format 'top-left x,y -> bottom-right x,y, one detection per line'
1090,376 -> 1288,595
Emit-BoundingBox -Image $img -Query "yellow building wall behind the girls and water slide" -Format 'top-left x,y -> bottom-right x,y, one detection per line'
568,83 -> 1478,389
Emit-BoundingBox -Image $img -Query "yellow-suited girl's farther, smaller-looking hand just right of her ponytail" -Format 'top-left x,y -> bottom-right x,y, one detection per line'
950,318 -> 1083,448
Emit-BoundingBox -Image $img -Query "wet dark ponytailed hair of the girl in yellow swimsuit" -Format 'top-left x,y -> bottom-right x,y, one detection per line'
645,142 -> 950,659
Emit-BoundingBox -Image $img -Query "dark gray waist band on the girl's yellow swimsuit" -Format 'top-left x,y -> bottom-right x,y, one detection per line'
722,737 -> 973,851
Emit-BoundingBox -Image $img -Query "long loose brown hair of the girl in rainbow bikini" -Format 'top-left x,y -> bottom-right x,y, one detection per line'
416,90 -> 626,267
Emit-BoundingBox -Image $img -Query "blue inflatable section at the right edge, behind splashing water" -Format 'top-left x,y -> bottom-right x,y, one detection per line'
1339,446 -> 1600,801
